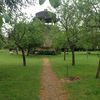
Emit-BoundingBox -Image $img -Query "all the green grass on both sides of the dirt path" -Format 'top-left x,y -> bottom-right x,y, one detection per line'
0,50 -> 100,100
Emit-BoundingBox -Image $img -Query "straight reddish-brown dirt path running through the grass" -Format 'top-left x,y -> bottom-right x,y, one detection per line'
40,58 -> 67,100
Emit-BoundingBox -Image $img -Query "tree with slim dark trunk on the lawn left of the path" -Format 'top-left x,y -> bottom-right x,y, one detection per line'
9,21 -> 28,66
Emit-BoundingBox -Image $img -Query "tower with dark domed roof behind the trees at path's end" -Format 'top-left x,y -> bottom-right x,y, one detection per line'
36,9 -> 58,55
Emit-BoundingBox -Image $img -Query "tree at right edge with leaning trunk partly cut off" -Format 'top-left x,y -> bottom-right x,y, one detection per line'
73,0 -> 100,78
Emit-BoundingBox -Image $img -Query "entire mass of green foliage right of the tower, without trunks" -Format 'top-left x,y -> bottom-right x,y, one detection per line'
58,0 -> 100,49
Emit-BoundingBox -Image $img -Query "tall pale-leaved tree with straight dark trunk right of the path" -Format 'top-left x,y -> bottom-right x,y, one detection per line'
58,0 -> 80,65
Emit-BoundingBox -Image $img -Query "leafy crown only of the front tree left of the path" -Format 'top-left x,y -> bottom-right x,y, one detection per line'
11,22 -> 27,48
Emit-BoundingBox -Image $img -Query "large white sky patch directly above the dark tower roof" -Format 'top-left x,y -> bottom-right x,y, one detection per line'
22,0 -> 56,18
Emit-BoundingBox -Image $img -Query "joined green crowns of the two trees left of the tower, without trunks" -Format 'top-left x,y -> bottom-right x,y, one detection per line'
10,19 -> 45,49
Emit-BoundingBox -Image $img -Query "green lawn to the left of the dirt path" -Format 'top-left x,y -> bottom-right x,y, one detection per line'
0,50 -> 42,100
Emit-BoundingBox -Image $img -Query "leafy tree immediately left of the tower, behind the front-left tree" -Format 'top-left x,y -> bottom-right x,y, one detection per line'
27,19 -> 45,55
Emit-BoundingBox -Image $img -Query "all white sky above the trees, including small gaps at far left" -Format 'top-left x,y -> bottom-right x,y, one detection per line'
2,0 -> 56,32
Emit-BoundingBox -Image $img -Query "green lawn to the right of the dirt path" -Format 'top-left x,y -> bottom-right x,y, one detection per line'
49,52 -> 100,100
